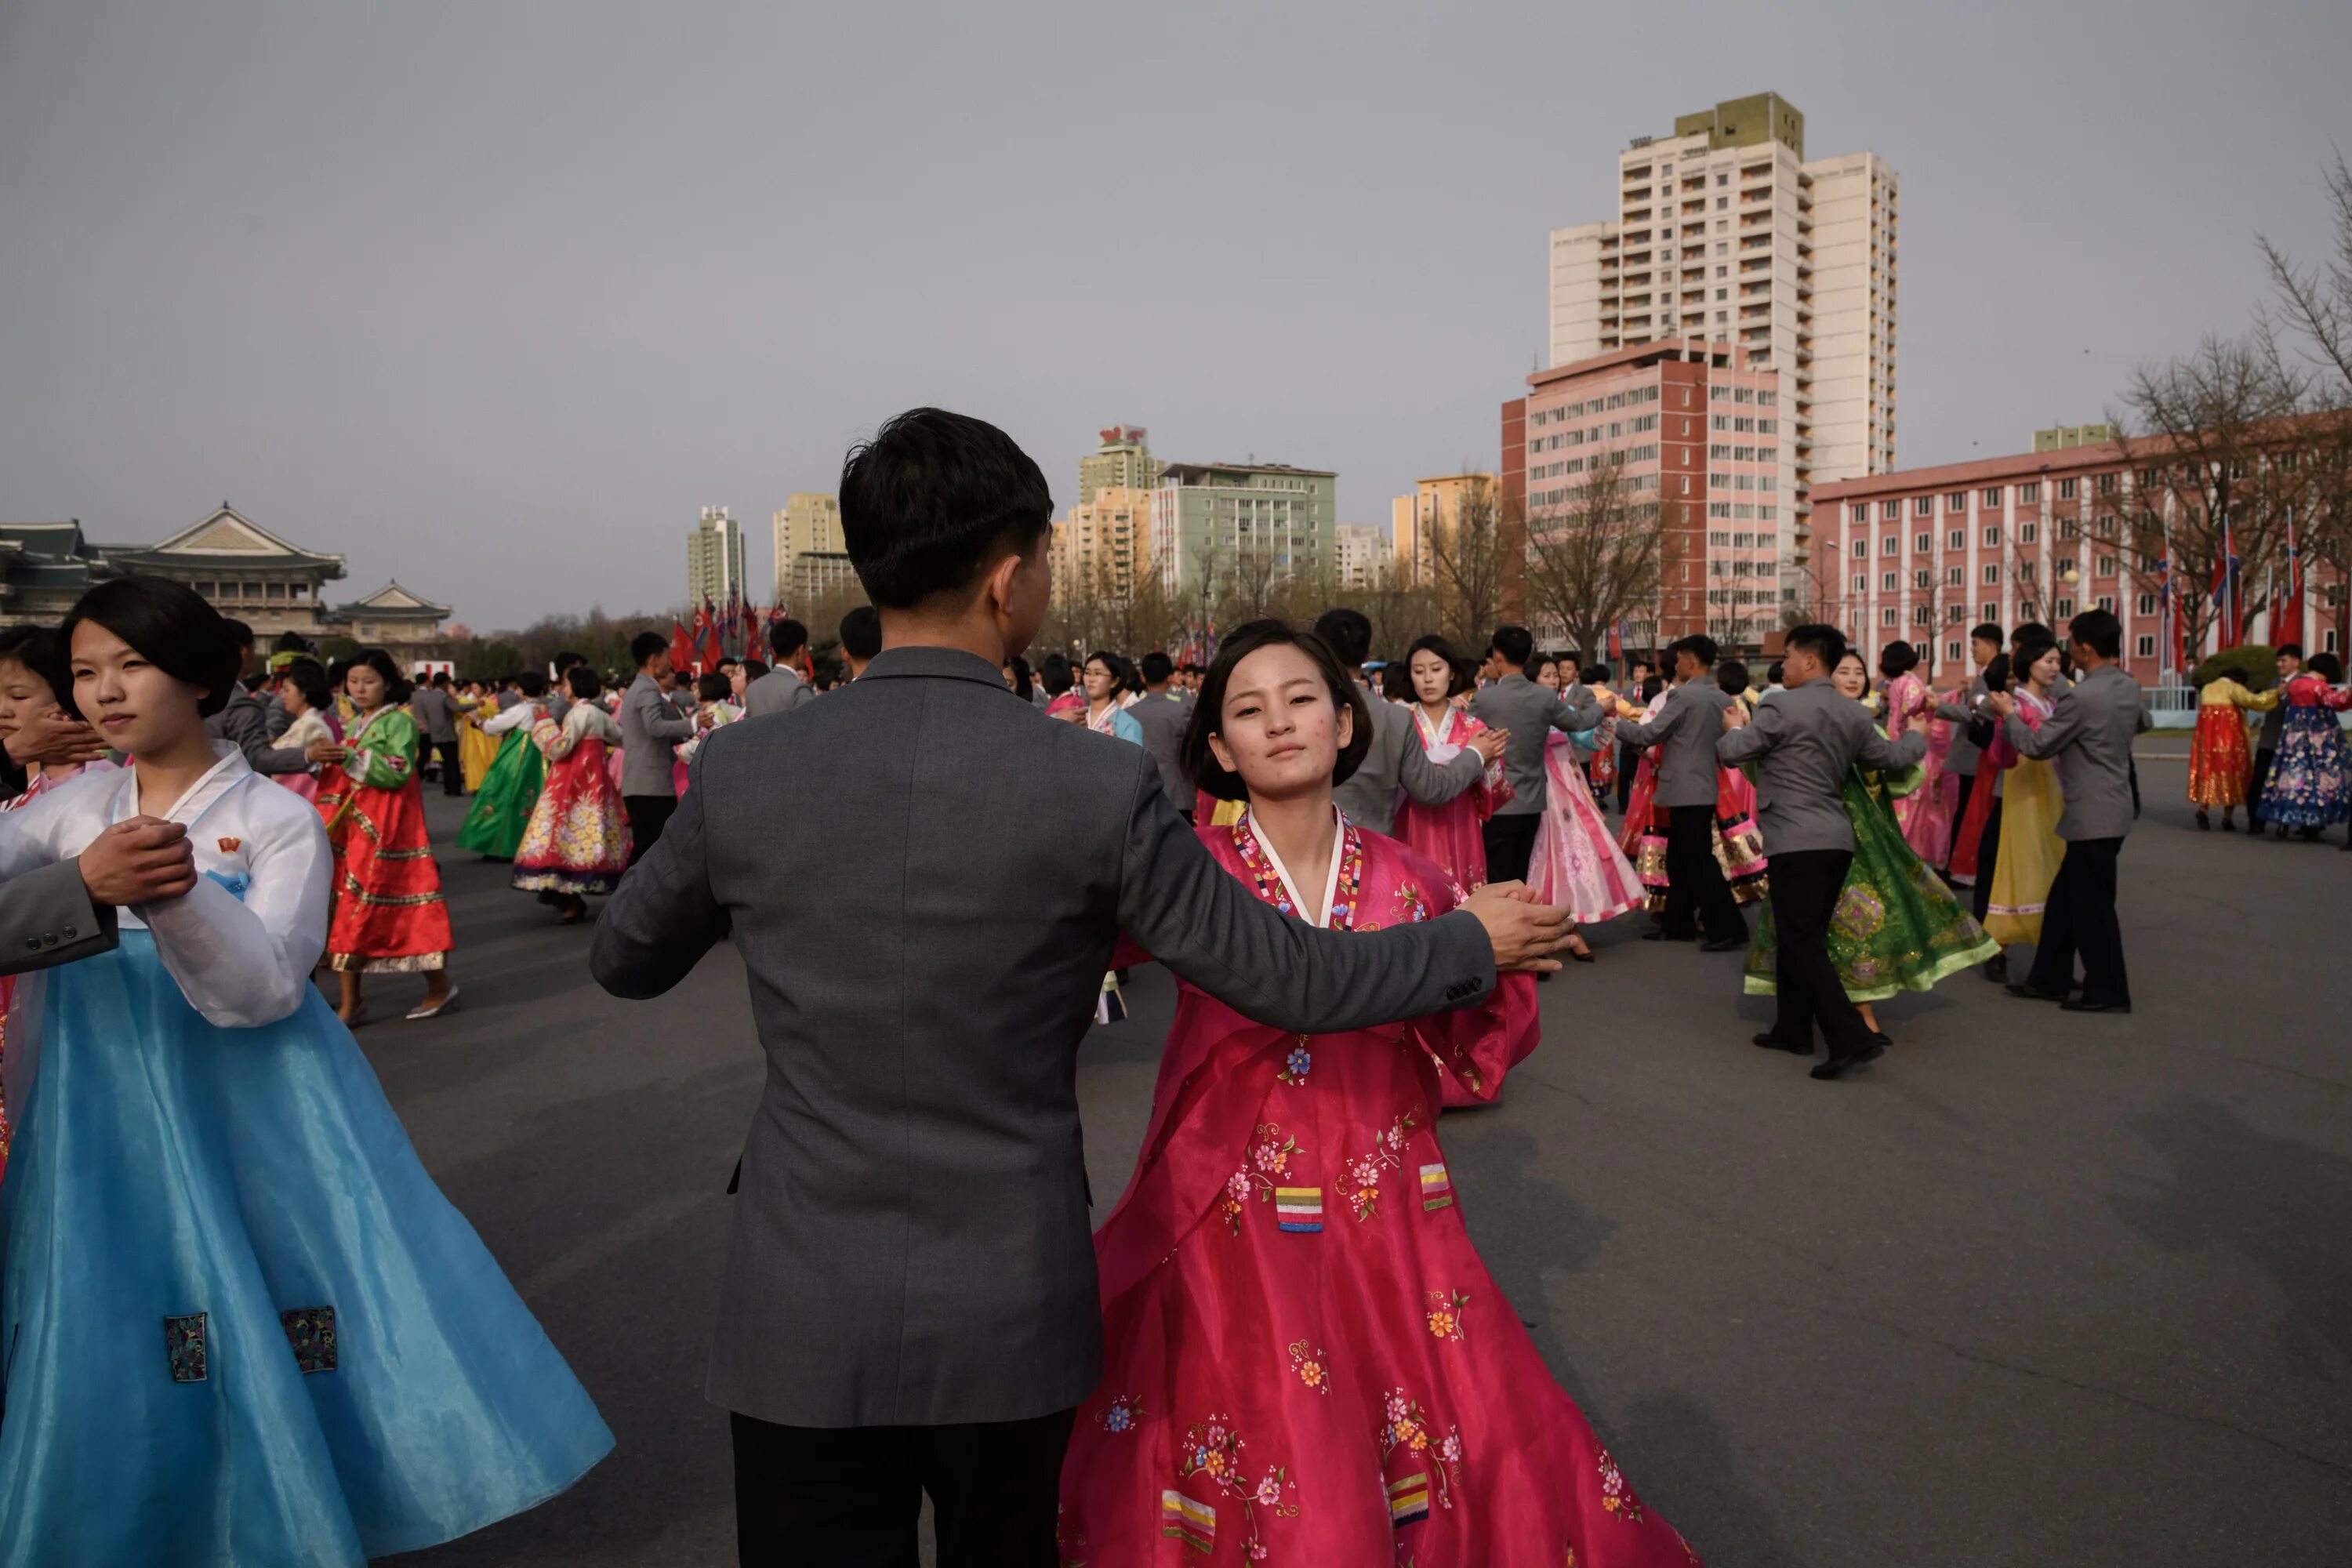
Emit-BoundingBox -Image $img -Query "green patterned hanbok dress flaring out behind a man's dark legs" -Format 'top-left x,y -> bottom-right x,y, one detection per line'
1745,738 -> 2002,1001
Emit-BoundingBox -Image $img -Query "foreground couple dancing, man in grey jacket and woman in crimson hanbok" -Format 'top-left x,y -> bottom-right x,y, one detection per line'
593,409 -> 1693,1568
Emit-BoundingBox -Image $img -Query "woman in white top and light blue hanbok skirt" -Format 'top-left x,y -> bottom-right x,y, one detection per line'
0,579 -> 612,1568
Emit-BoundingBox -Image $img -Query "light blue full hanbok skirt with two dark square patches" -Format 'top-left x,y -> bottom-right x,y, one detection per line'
0,931 -> 612,1568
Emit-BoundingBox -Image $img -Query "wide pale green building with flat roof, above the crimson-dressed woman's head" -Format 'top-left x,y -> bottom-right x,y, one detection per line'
1150,463 -> 1338,595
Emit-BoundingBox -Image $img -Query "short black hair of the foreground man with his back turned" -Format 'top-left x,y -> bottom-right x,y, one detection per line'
842,409 -> 1054,609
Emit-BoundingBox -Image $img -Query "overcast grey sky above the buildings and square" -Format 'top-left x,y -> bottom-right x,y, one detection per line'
0,0 -> 2352,628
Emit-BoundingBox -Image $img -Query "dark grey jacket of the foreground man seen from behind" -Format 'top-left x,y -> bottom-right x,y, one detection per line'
590,649 -> 1494,1427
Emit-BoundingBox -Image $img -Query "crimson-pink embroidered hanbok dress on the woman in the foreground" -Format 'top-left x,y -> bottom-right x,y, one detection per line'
1061,818 -> 1698,1568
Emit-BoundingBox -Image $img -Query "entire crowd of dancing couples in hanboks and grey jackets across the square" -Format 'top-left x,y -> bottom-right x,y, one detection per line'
0,409 -> 2352,1566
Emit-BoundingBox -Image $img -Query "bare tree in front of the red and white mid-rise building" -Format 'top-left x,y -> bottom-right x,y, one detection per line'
1526,454 -> 1665,659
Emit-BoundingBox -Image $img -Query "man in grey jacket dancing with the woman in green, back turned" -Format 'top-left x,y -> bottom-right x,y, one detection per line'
1722,626 -> 1926,1079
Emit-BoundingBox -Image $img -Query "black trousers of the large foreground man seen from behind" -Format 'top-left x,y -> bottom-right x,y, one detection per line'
729,1410 -> 1077,1568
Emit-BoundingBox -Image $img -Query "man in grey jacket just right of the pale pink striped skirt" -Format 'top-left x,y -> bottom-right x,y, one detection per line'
1618,635 -> 1740,952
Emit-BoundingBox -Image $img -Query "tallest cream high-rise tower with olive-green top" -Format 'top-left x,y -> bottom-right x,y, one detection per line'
1552,92 -> 1896,604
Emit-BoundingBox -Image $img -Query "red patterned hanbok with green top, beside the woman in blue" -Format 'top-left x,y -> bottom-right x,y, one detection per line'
318,703 -> 454,973
